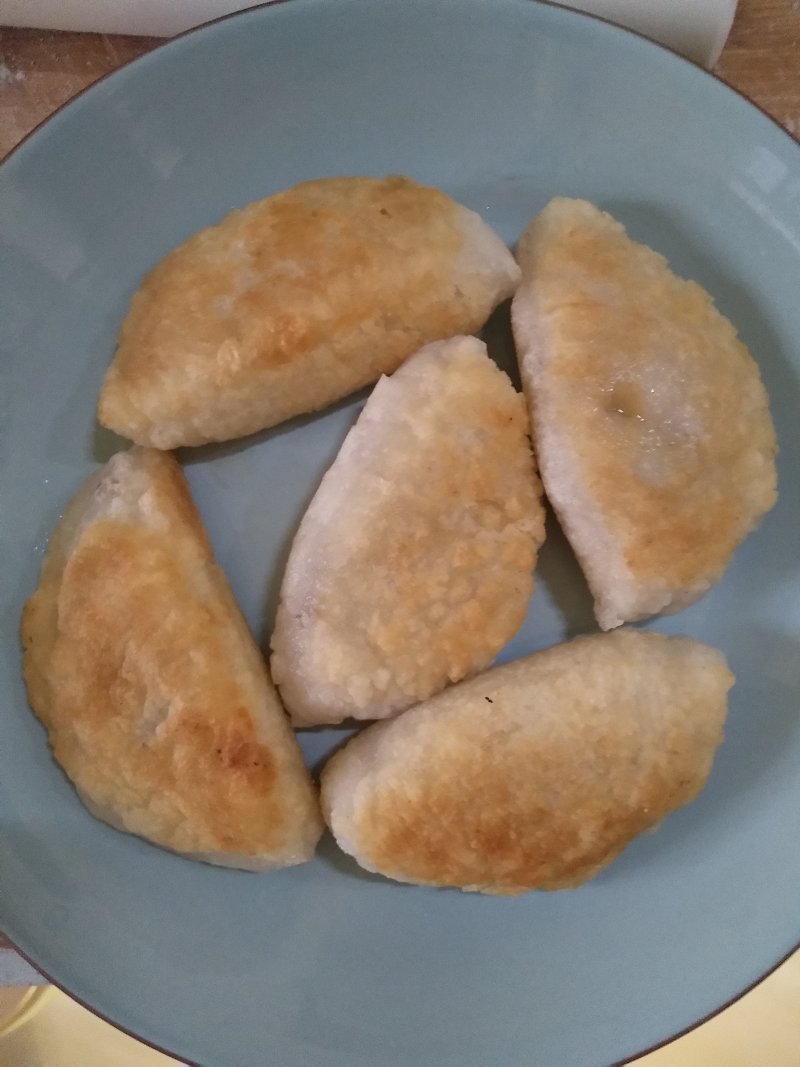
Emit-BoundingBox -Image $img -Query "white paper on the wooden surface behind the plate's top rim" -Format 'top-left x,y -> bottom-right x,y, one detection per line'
0,0 -> 736,66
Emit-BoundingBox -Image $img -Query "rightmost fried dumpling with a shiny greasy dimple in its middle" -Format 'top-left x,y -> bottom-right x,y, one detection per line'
512,198 -> 777,630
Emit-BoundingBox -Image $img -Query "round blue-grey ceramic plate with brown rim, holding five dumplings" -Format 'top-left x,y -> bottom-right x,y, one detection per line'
0,0 -> 800,1067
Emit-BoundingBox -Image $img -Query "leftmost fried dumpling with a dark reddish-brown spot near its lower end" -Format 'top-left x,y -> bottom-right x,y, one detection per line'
22,448 -> 320,867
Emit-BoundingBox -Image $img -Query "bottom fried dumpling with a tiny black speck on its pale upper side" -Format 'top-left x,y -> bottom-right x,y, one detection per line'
322,630 -> 733,893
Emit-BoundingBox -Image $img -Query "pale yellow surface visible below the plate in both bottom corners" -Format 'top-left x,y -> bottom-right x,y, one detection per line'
0,953 -> 800,1067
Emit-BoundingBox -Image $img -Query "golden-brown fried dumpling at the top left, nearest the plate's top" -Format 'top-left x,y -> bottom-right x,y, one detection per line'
98,177 -> 518,448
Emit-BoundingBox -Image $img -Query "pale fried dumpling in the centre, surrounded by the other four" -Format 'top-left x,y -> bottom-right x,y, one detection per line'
272,337 -> 544,726
